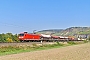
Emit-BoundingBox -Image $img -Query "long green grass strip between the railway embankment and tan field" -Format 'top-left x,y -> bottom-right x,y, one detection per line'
0,42 -> 87,56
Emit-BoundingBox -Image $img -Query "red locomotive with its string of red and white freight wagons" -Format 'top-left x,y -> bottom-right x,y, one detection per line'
19,32 -> 75,42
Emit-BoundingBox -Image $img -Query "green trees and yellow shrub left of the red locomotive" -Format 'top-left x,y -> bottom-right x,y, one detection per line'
0,33 -> 19,42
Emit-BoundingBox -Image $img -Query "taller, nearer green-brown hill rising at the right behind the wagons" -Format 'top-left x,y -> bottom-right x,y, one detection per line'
60,27 -> 90,36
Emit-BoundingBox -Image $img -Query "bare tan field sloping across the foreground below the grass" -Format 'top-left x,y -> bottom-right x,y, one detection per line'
0,43 -> 90,60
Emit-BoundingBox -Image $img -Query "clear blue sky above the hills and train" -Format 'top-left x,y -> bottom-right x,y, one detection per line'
0,0 -> 90,33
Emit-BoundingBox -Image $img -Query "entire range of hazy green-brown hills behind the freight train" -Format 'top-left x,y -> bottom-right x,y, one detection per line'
37,27 -> 90,36
